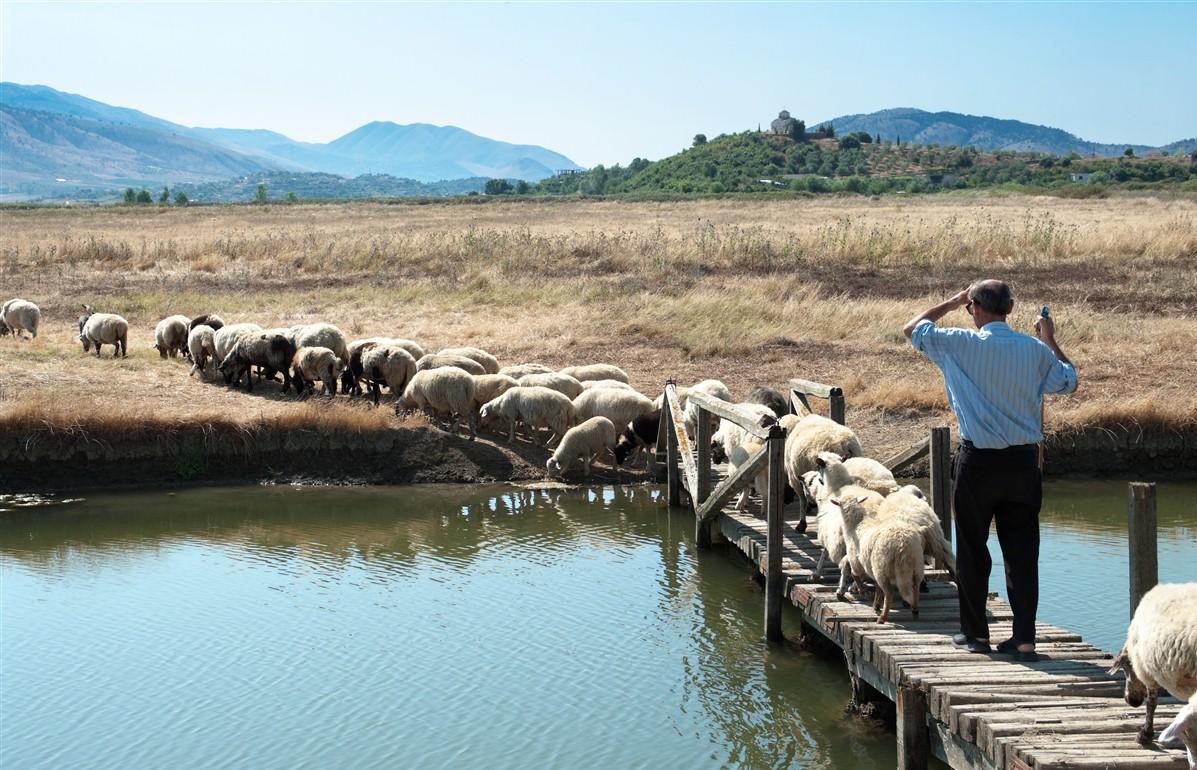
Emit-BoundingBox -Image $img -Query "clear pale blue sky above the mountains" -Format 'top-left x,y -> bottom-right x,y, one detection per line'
0,0 -> 1197,166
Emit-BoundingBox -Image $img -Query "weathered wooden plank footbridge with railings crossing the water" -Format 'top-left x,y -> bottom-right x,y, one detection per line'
650,380 -> 1189,770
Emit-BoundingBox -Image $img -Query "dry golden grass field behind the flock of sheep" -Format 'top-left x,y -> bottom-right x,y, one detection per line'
0,198 -> 1197,467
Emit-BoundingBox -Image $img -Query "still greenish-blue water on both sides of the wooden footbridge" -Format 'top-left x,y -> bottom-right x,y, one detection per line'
0,483 -> 1197,769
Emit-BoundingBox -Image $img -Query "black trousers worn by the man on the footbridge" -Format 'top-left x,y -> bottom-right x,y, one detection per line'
952,444 -> 1043,644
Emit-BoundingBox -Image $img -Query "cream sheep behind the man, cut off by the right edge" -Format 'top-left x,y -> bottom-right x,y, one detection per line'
1110,583 -> 1197,757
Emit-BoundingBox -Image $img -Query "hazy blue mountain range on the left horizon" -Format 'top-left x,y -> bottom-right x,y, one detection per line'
0,83 -> 578,195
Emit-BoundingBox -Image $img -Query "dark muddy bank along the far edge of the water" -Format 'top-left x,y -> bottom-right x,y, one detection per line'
0,426 -> 1197,492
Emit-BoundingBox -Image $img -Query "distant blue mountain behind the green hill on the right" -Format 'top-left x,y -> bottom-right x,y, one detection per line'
812,107 -> 1197,157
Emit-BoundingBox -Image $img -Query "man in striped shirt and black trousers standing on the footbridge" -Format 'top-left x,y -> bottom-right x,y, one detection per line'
903,280 -> 1076,661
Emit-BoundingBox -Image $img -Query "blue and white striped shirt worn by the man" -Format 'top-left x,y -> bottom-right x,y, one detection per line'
910,320 -> 1076,449
